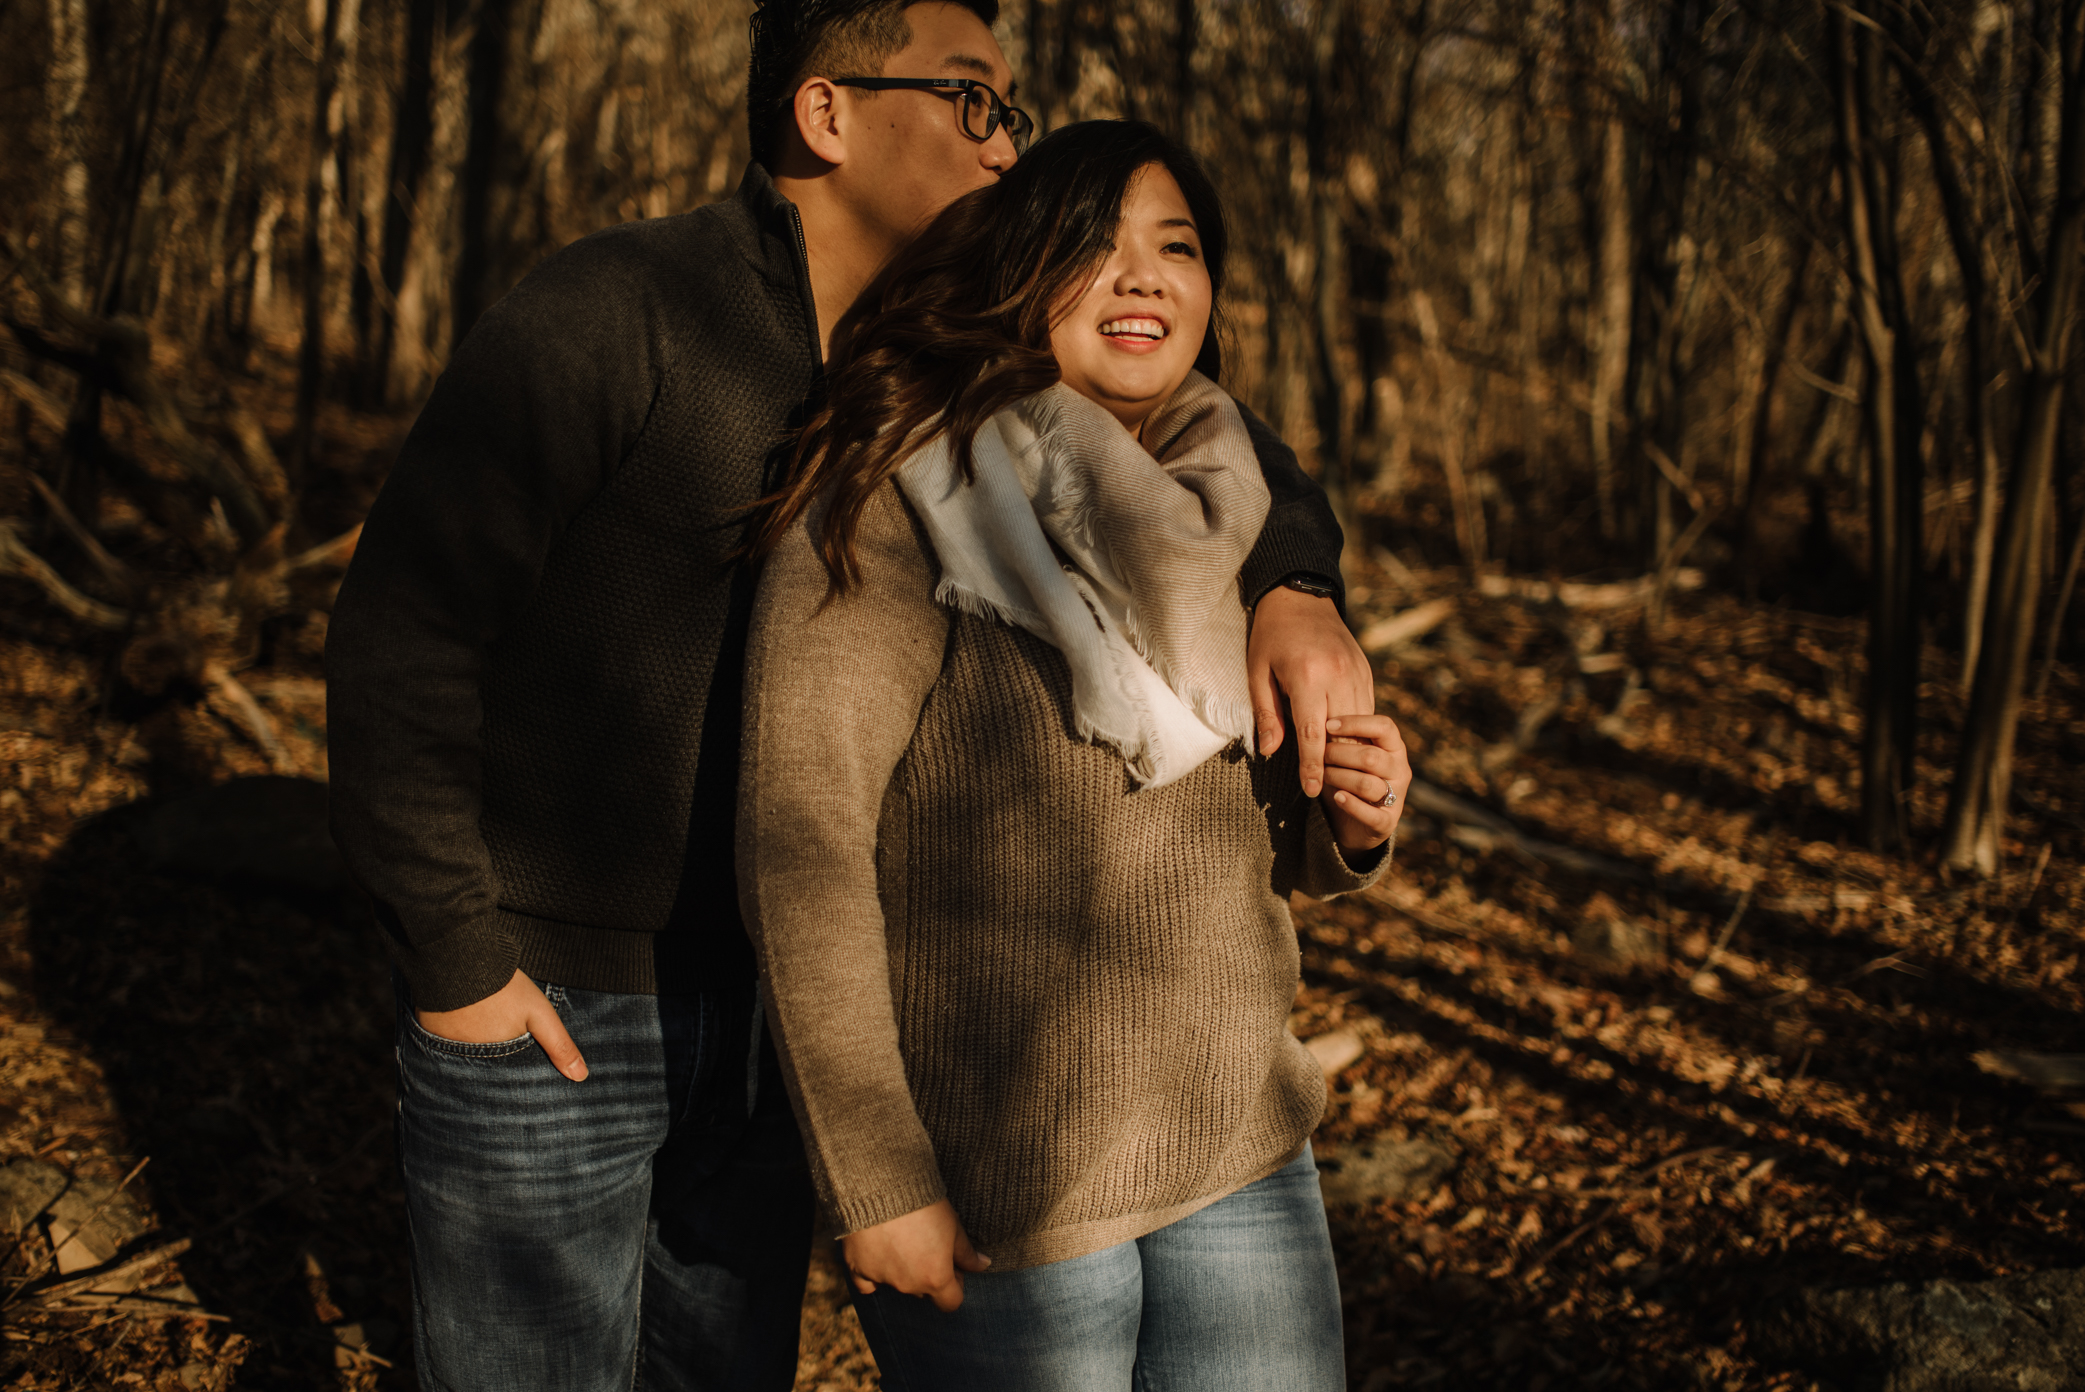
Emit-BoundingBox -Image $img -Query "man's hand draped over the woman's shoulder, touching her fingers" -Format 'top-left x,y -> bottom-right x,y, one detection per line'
1245,586 -> 1376,798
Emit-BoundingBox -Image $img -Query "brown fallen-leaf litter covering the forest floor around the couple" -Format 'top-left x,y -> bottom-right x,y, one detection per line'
0,550 -> 2085,1392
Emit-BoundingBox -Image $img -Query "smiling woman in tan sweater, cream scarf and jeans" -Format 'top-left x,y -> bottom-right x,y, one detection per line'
738,121 -> 1409,1392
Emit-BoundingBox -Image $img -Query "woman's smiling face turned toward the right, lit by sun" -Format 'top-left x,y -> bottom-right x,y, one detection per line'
1049,165 -> 1213,436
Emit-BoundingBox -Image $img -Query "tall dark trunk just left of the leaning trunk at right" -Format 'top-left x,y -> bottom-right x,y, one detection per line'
1833,13 -> 1922,850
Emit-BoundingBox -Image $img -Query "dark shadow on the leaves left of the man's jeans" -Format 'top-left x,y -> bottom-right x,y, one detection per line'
27,792 -> 409,1388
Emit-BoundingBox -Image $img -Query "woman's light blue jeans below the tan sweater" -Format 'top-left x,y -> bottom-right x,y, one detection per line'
855,1146 -> 1347,1392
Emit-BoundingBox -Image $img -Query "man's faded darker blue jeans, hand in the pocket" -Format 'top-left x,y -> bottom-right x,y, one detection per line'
398,984 -> 811,1392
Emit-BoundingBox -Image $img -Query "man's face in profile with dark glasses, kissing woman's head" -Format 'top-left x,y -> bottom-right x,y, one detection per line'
834,4 -> 1015,240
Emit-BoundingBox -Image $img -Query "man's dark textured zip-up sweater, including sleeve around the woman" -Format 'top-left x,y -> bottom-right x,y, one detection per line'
325,165 -> 1341,1011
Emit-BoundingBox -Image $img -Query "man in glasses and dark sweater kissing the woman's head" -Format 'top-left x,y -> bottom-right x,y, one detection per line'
327,0 -> 1372,1392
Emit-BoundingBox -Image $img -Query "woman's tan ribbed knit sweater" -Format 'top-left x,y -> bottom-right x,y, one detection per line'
738,486 -> 1389,1269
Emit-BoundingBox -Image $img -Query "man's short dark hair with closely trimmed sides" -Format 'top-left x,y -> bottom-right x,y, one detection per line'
746,0 -> 999,167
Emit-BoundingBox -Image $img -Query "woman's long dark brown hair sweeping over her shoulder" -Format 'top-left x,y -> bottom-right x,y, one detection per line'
744,121 -> 1226,594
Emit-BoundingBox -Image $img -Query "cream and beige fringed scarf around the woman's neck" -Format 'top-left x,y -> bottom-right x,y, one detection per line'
899,373 -> 1268,788
